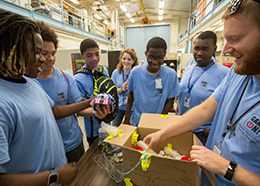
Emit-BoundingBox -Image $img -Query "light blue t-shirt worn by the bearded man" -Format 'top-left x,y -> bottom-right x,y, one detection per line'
202,65 -> 260,186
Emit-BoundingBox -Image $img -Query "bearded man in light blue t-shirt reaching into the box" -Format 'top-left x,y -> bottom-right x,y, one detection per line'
144,0 -> 260,186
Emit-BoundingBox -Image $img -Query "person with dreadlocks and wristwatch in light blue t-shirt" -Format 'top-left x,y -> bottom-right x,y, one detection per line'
0,9 -> 77,186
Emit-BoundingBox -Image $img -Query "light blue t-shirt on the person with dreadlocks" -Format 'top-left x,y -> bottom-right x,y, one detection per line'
0,77 -> 67,173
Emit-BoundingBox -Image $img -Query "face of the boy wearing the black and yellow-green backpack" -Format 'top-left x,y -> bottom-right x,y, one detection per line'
80,48 -> 100,70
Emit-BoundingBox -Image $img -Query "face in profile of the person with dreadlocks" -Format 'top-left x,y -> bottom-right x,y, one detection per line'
26,33 -> 45,78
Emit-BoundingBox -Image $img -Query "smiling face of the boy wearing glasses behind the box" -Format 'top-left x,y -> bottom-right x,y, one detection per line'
145,48 -> 165,73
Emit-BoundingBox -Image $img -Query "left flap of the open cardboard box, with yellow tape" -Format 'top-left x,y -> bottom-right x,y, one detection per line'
104,124 -> 136,147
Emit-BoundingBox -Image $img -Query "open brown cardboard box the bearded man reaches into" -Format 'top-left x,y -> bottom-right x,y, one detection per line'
105,114 -> 214,186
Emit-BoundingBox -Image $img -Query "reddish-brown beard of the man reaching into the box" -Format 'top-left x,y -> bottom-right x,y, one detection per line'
234,39 -> 260,75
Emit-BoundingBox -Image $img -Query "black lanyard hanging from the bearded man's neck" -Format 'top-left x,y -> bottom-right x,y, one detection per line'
221,76 -> 260,141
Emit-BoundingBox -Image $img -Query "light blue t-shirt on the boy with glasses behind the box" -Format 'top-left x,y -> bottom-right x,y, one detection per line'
128,64 -> 180,126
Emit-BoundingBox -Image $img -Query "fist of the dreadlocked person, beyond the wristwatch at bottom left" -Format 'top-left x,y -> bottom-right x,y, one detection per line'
56,162 -> 78,185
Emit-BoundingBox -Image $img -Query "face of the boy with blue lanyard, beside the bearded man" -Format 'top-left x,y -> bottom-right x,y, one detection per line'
193,39 -> 217,67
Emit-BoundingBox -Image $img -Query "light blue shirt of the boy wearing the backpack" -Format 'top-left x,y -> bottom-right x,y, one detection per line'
74,65 -> 109,137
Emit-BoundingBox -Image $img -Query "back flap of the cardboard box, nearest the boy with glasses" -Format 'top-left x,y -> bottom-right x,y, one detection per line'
138,113 -> 182,130
